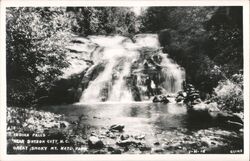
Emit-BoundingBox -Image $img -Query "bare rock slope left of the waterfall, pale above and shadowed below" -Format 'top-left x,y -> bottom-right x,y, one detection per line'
35,37 -> 98,105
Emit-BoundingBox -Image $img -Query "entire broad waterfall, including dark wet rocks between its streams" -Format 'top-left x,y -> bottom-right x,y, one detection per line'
80,34 -> 185,102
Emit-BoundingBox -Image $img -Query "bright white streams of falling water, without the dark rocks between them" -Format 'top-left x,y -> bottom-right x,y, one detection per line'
80,34 -> 185,103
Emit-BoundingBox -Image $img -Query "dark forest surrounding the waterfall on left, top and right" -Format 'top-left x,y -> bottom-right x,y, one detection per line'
6,7 -> 243,113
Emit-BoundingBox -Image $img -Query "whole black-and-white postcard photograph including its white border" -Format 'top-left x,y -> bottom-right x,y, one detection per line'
1,2 -> 249,159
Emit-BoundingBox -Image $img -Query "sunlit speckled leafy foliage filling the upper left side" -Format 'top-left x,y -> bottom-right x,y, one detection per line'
6,7 -> 71,106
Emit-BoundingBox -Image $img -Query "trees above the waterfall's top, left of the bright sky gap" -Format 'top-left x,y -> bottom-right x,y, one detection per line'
67,7 -> 137,36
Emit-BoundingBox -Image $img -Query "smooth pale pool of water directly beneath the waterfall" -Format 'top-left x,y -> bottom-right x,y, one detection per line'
43,103 -> 188,133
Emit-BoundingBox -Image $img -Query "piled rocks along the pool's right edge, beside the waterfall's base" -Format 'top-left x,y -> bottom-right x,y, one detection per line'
175,84 -> 244,131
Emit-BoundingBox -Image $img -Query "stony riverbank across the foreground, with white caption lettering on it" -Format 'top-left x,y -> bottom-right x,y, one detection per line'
7,107 -> 243,154
